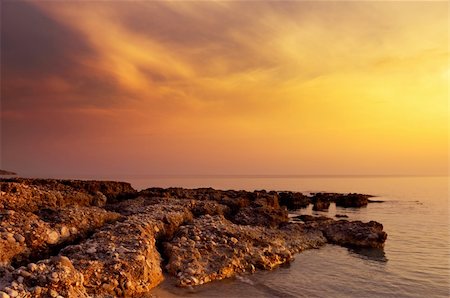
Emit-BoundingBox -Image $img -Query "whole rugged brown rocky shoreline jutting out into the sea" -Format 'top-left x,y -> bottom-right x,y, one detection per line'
0,178 -> 387,298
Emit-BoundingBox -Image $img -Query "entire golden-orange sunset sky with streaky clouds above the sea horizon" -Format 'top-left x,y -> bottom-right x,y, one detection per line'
0,0 -> 449,177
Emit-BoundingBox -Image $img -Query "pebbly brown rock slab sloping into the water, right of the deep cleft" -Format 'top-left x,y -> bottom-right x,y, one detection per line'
165,215 -> 326,286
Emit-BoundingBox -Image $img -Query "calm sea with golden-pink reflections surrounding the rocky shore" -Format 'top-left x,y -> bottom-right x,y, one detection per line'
69,177 -> 450,297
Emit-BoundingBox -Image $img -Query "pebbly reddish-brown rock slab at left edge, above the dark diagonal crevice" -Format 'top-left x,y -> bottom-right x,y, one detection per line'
0,207 -> 120,265
